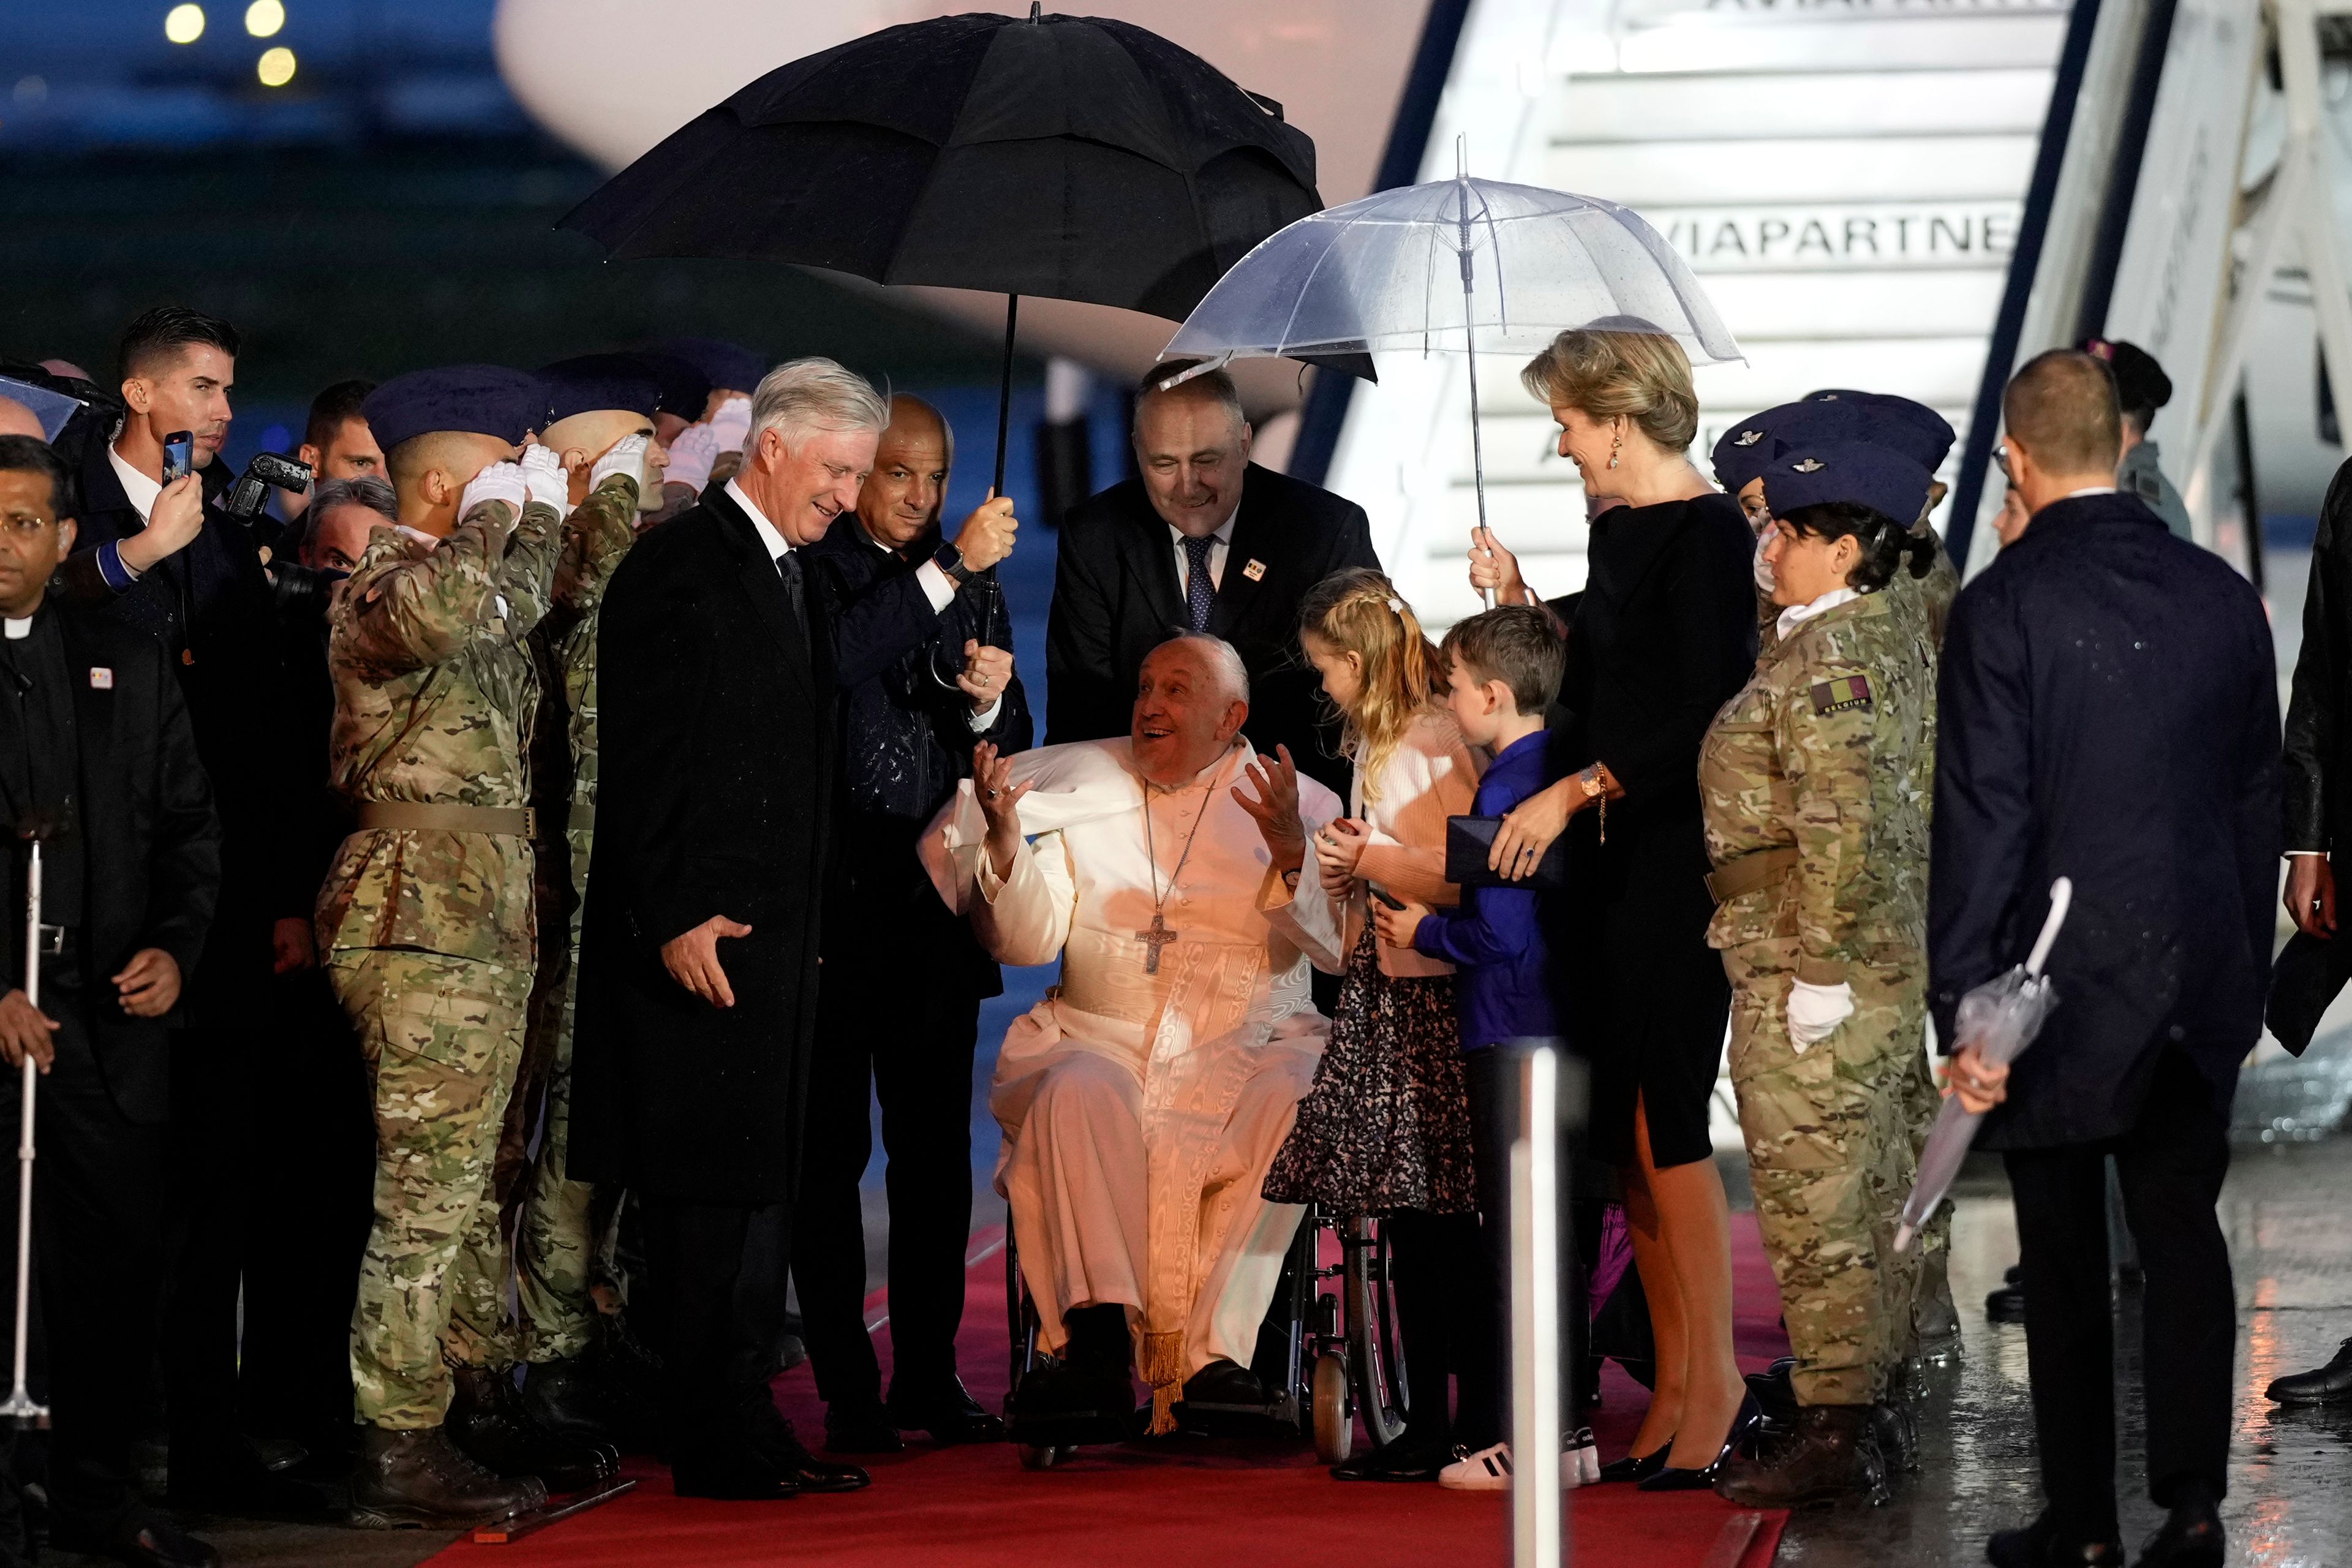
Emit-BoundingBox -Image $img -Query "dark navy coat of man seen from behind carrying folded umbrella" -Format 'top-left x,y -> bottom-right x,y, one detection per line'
1929,496 -> 2279,1150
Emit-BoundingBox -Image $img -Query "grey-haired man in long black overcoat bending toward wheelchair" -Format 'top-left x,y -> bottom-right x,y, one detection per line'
569,360 -> 1011,1500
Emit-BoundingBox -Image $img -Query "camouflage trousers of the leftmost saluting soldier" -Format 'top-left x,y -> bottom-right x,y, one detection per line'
327,948 -> 532,1430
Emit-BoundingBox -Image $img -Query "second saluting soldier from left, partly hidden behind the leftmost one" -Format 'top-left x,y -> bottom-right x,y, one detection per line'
500,355 -> 668,1439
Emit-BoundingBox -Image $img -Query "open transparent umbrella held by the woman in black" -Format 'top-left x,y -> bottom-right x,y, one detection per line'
1164,143 -> 1741,601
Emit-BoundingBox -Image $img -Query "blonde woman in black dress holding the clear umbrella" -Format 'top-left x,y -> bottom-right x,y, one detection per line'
1472,322 -> 1757,1490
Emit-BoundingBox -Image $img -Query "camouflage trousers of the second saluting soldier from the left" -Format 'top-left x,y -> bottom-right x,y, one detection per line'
515,948 -> 597,1361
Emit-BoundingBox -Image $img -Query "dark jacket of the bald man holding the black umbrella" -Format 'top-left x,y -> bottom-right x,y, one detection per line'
809,517 -> 1035,997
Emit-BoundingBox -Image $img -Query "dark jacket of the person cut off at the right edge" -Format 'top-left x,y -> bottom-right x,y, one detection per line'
2286,447 -> 2352,849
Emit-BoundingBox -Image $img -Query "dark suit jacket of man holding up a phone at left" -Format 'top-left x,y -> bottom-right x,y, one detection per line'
59,442 -> 308,1027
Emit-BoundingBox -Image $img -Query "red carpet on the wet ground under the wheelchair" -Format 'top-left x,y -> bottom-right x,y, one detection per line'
433,1215 -> 1785,1568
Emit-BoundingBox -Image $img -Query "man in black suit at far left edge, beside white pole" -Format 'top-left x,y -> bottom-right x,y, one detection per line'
0,435 -> 221,1568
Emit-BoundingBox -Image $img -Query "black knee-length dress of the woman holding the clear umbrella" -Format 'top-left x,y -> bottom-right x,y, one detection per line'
1545,494 -> 1757,1166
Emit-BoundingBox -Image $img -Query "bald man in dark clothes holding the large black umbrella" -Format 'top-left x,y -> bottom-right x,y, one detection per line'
793,395 -> 1033,1453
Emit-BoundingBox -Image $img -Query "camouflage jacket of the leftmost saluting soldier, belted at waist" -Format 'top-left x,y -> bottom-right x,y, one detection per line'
317,501 -> 560,968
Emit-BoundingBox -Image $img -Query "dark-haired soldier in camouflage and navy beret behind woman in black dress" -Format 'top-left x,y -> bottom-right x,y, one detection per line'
1698,442 -> 1936,1507
